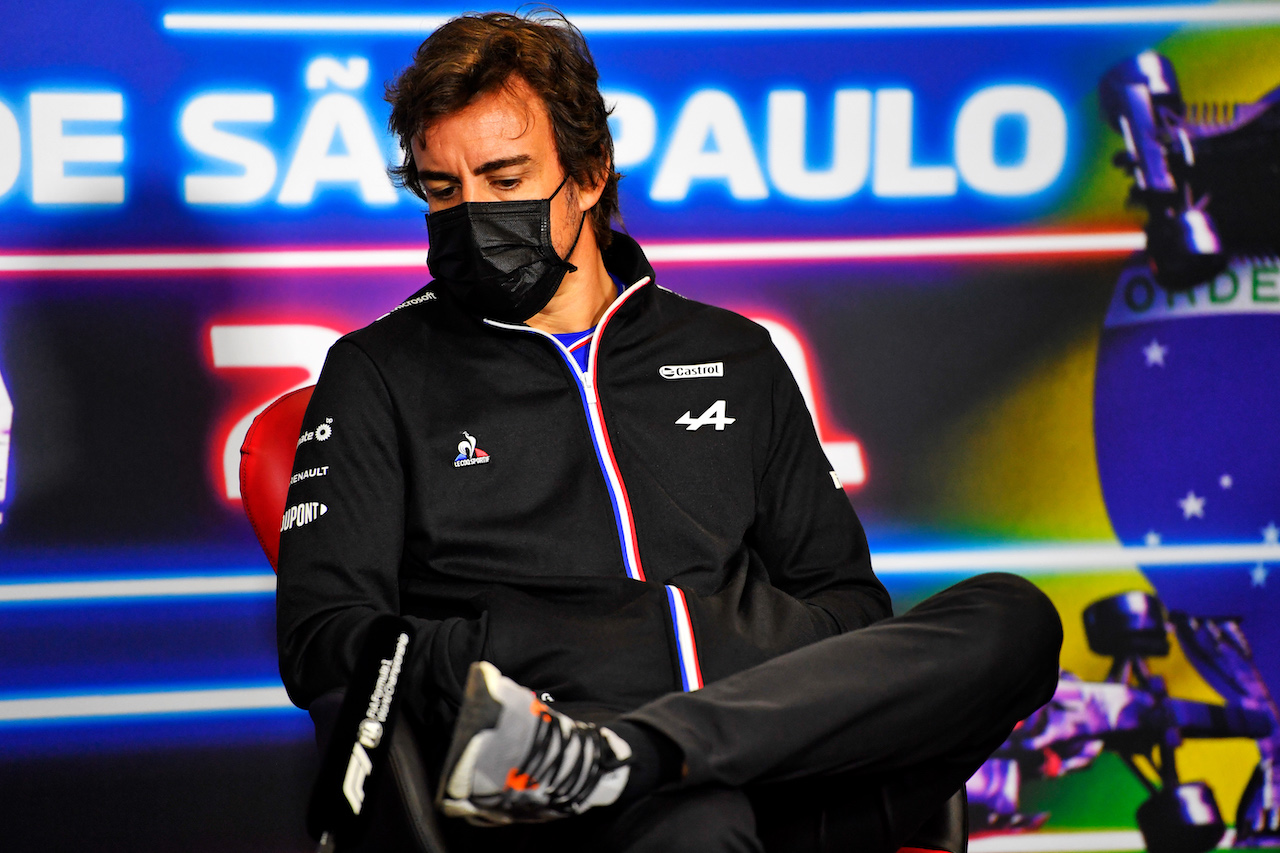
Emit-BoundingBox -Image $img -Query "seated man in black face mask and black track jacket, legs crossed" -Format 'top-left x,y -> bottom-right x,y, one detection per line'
279,14 -> 1061,853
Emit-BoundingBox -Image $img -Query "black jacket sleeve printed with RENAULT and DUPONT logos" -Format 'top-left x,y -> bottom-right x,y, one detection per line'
276,339 -> 483,721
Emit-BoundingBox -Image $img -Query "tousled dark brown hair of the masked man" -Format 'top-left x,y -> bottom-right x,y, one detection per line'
387,12 -> 620,248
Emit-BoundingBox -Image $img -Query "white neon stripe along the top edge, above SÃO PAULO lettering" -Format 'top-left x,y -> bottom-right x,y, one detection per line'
163,3 -> 1280,35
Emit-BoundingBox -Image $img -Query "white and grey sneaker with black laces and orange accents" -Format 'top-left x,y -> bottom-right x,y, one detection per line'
435,661 -> 631,826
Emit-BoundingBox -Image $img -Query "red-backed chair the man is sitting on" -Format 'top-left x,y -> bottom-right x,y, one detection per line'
239,386 -> 969,853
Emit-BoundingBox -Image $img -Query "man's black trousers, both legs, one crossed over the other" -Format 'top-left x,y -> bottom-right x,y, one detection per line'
443,574 -> 1062,853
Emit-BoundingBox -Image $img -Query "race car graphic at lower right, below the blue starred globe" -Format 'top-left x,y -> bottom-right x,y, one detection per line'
966,590 -> 1280,853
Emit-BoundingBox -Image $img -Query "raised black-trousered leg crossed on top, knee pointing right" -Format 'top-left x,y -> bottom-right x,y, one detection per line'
623,574 -> 1062,844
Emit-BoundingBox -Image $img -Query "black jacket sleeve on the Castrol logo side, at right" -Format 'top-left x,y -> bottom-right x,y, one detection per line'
749,345 -> 892,633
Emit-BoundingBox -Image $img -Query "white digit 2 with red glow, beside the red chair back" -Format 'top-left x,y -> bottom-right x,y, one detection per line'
209,324 -> 342,501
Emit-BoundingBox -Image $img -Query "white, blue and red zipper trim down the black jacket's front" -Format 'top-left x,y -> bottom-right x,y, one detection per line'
485,275 -> 703,690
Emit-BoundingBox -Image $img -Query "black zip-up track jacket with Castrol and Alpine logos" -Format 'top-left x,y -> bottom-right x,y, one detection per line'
278,234 -> 890,725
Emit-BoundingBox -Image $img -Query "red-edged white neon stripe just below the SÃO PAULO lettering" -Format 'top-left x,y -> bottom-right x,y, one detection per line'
0,231 -> 1147,275
